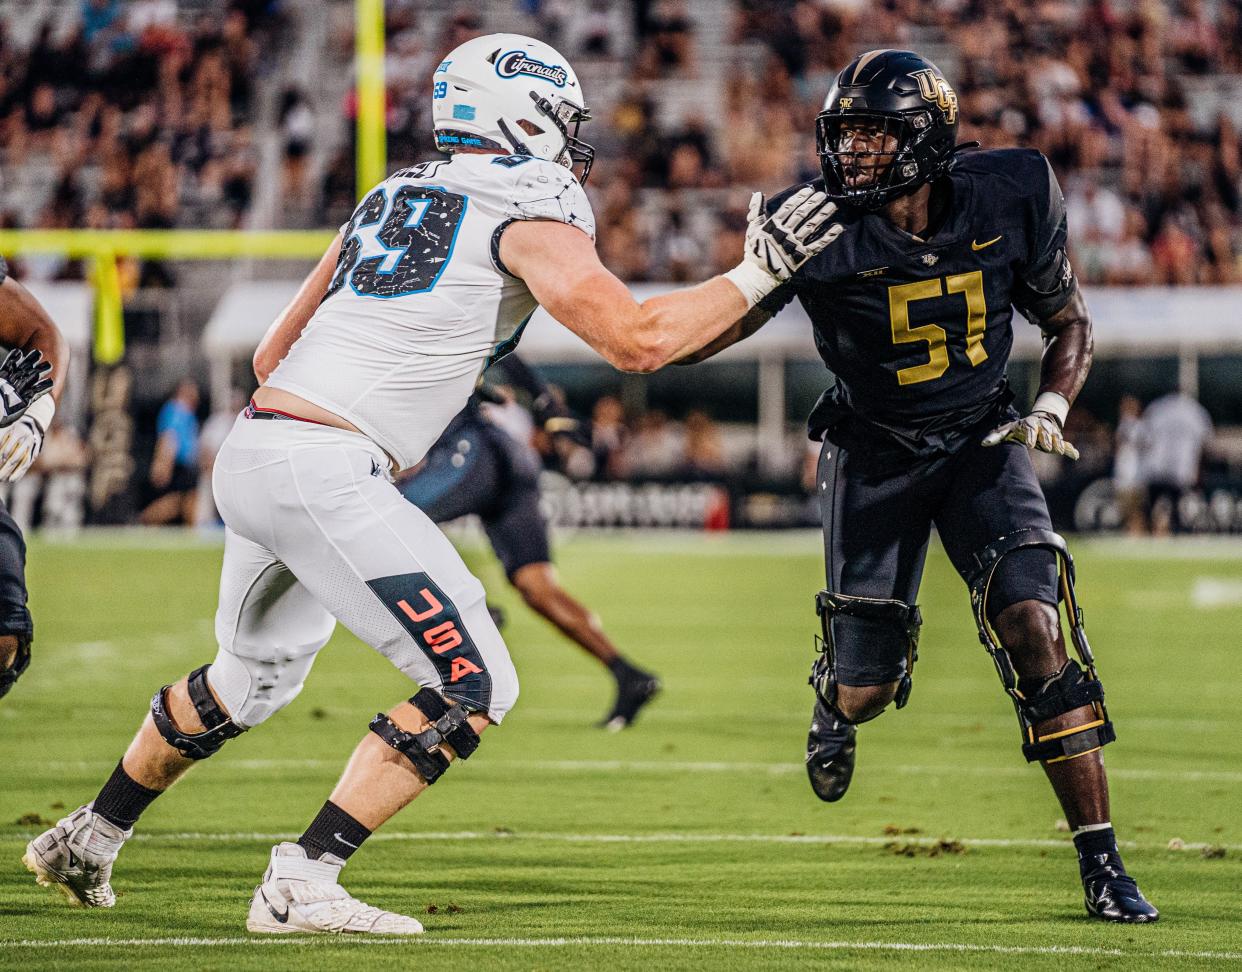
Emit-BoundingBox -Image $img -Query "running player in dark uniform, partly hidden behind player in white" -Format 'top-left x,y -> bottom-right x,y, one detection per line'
392,349 -> 660,731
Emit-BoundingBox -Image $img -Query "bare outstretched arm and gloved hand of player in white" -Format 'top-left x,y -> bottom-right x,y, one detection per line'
501,187 -> 841,372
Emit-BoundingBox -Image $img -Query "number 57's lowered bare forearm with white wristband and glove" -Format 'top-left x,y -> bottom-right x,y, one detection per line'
984,288 -> 1094,459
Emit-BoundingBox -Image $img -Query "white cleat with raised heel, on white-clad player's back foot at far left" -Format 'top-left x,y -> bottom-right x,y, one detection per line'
21,806 -> 133,907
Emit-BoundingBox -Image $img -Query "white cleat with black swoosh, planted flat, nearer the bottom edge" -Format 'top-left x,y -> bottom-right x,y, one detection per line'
246,842 -> 422,935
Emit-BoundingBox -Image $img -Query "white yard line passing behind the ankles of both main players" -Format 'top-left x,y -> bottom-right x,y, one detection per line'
9,829 -> 1242,852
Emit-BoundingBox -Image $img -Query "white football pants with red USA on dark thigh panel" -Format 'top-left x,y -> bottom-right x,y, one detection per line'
207,416 -> 518,727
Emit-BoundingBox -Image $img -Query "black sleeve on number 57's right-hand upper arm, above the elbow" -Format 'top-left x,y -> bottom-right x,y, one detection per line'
1013,155 -> 1078,324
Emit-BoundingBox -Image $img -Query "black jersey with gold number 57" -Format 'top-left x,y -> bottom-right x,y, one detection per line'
763,149 -> 1077,454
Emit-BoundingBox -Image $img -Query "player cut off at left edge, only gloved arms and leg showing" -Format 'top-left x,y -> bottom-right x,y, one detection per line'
0,258 -> 70,698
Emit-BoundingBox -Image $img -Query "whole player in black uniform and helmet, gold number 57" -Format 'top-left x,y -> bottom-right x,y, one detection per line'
691,51 -> 1158,922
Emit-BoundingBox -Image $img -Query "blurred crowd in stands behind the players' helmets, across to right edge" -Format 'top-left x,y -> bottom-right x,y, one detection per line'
315,0 -> 1242,284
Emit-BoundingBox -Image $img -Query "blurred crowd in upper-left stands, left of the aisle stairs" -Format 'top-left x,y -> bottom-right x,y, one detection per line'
0,0 -> 276,286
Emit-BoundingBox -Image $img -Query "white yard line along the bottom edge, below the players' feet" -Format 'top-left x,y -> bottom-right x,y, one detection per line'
0,935 -> 1242,962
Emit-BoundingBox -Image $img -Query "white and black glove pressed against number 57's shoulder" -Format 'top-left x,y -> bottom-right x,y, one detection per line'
724,186 -> 845,307
